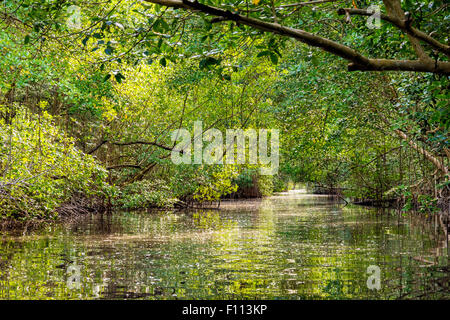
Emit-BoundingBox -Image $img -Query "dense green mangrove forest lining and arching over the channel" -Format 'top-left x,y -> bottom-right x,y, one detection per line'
0,0 -> 450,221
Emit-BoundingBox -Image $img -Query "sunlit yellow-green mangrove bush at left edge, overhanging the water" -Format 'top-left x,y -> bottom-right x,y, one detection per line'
0,101 -> 109,219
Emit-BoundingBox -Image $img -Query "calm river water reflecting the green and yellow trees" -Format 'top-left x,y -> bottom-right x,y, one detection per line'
0,192 -> 450,299
